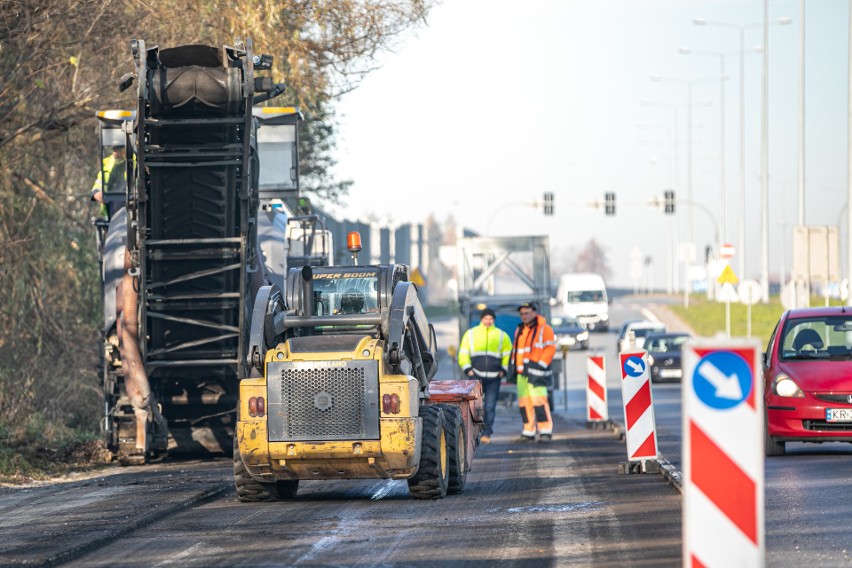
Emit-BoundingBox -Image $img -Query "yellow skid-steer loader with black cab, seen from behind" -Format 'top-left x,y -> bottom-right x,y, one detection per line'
234,265 -> 483,501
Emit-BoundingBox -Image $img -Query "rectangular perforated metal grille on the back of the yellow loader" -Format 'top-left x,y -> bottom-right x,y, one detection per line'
267,361 -> 379,442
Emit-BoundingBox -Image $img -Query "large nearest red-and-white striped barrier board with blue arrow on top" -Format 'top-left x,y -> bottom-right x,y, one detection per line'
683,340 -> 765,566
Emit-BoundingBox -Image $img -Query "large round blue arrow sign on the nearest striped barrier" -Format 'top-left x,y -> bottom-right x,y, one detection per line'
692,351 -> 754,410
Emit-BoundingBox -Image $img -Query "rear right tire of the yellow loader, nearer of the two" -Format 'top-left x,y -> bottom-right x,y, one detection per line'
408,405 -> 450,499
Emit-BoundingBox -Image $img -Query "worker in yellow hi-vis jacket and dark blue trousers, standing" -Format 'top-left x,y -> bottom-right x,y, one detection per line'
459,308 -> 512,444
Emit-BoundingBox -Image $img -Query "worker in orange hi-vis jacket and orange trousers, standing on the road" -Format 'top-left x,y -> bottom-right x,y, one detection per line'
512,302 -> 556,442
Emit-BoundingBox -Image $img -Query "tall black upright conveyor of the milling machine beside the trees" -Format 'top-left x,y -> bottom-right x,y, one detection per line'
96,40 -> 295,464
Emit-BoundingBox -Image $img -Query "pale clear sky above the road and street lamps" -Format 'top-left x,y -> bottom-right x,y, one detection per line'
324,0 -> 848,288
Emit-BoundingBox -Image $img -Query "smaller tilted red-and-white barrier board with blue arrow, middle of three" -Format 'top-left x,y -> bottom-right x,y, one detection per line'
618,349 -> 657,461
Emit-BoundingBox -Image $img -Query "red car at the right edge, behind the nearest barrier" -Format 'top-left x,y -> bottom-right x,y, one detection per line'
763,307 -> 852,456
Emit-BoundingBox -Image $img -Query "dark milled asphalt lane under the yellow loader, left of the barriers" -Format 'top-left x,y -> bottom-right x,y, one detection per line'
0,408 -> 681,567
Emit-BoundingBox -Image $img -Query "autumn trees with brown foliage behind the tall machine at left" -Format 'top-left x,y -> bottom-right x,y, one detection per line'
0,0 -> 431,443
